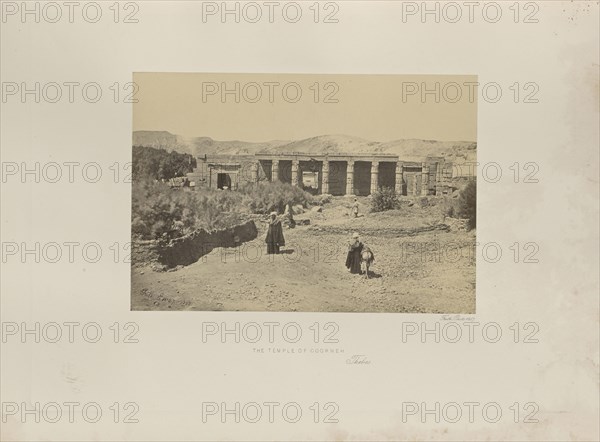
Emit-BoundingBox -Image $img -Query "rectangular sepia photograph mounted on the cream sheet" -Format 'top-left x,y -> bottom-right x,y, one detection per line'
131,73 -> 478,314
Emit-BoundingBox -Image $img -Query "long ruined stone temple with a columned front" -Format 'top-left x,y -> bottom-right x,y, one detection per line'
187,152 -> 452,196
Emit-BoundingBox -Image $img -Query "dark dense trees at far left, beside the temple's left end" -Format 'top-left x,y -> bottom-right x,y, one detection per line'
132,146 -> 196,181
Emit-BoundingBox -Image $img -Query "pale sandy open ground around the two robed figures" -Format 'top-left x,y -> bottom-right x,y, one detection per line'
132,198 -> 475,314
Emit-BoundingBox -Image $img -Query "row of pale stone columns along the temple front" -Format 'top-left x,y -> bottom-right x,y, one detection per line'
252,160 -> 429,196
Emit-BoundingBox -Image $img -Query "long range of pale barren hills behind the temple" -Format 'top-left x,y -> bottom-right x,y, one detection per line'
133,131 -> 477,163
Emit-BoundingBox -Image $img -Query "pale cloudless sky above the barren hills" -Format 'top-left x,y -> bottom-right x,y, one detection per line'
133,73 -> 477,142
